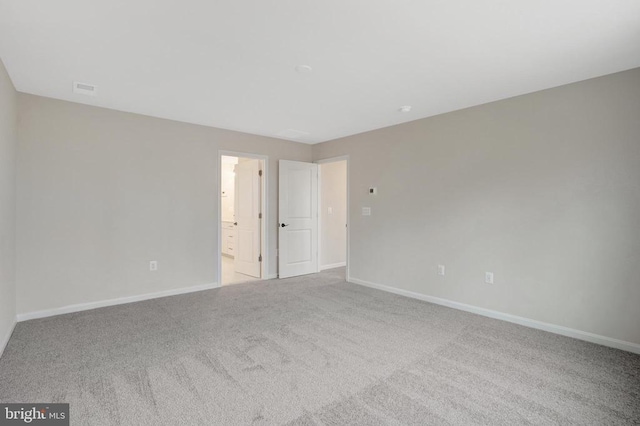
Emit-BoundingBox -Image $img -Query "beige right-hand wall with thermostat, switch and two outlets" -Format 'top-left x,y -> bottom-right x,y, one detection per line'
314,69 -> 640,343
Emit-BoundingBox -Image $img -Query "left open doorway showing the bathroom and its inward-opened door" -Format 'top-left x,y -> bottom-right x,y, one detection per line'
218,152 -> 266,285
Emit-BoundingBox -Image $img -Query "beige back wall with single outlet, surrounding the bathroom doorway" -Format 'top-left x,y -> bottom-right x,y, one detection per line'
17,94 -> 311,314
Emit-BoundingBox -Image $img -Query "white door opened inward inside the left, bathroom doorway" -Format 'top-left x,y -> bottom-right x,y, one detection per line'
234,160 -> 262,278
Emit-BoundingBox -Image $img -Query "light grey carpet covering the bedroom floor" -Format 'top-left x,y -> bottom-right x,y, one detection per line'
0,269 -> 640,425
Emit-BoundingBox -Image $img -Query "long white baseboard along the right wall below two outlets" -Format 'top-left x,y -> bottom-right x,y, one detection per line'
347,278 -> 640,354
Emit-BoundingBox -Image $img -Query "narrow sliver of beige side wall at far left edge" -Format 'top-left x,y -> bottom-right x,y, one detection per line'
0,60 -> 18,354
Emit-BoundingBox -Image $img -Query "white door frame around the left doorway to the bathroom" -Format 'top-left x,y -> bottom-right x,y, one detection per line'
216,150 -> 269,287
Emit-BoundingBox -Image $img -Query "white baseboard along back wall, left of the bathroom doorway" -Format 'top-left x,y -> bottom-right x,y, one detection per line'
17,283 -> 220,322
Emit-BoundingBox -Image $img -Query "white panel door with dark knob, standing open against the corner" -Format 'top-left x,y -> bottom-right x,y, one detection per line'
278,160 -> 318,278
